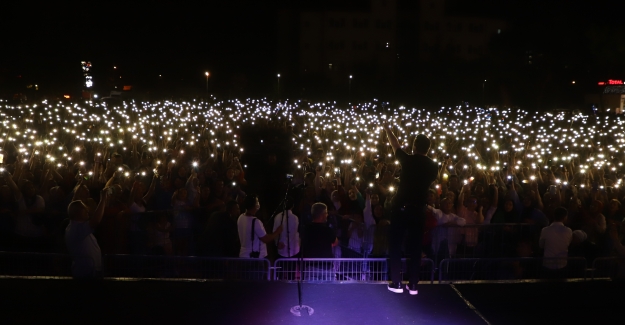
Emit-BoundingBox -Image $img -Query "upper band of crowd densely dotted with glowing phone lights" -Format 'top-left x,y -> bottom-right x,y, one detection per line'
0,99 -> 625,189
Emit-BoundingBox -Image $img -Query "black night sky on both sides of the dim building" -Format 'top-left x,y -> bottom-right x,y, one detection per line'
0,0 -> 625,105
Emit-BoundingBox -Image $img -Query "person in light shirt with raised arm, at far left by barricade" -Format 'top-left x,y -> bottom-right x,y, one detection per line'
65,188 -> 110,279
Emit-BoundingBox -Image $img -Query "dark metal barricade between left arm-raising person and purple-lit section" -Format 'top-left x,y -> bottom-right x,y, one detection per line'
103,255 -> 271,281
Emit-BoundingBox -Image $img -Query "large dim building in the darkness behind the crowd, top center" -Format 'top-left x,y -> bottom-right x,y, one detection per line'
277,0 -> 505,100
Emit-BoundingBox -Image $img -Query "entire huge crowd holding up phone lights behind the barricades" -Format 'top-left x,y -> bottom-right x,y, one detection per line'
0,99 -> 625,276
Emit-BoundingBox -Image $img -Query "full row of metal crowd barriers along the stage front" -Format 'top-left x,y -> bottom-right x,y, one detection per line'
0,252 -> 625,283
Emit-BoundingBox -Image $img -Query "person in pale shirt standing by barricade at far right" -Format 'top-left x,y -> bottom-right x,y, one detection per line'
539,207 -> 573,277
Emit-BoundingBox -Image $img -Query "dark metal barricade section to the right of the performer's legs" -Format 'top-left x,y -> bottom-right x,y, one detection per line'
438,257 -> 586,283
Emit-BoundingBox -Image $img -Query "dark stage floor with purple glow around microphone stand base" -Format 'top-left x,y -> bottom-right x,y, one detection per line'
0,279 -> 625,325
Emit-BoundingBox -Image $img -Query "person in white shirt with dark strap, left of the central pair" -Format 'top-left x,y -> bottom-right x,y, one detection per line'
237,195 -> 282,258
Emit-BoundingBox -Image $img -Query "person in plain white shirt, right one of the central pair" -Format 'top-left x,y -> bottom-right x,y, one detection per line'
273,199 -> 300,258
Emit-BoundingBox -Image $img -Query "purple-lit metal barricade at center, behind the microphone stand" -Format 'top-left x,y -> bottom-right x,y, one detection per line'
273,258 -> 434,283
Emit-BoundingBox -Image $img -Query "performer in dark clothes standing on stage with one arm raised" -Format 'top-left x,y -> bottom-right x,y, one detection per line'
383,124 -> 438,295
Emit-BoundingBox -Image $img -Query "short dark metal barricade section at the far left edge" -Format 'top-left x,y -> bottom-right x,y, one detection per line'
0,252 -> 72,277
